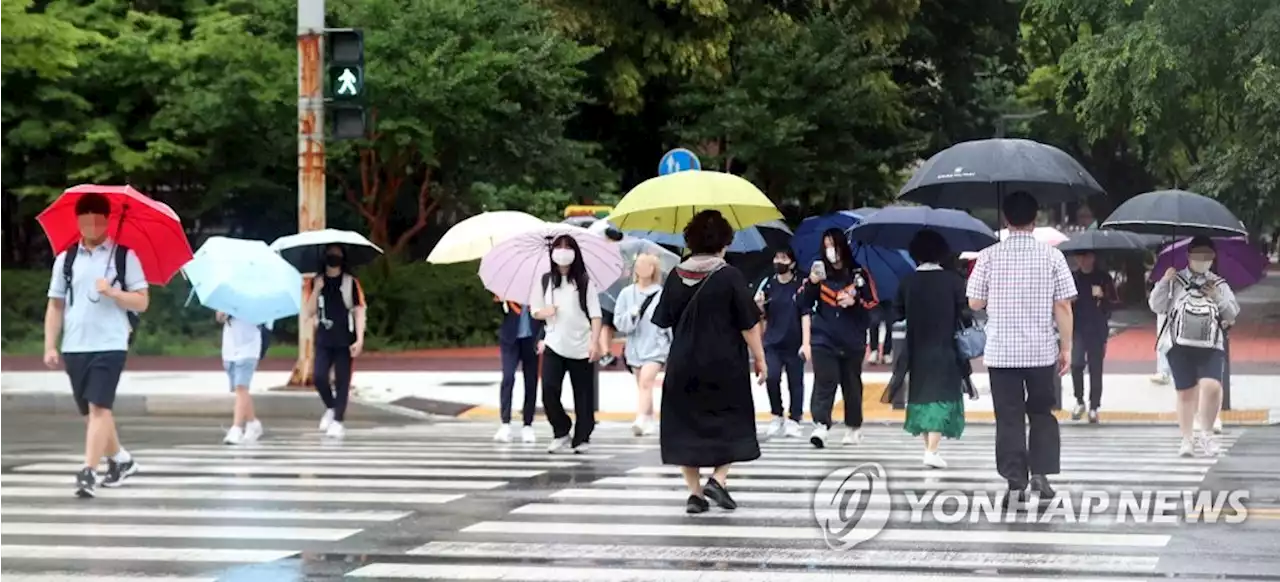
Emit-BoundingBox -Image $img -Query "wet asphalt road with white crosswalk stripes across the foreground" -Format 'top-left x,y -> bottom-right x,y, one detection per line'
0,412 -> 1280,582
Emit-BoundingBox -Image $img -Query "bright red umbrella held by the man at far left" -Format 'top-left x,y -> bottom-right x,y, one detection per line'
36,184 -> 192,285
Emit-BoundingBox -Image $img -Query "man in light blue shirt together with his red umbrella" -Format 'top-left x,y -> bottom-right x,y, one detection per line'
37,185 -> 191,498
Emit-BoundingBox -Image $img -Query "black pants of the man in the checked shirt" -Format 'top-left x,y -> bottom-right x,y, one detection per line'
987,366 -> 1062,489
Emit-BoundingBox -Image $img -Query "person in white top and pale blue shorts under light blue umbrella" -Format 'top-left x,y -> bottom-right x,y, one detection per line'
216,312 -> 262,445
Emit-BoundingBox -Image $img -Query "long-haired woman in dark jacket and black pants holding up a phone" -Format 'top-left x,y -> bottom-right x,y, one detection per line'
800,229 -> 879,449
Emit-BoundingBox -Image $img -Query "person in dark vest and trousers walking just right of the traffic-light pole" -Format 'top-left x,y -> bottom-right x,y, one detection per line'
306,244 -> 366,439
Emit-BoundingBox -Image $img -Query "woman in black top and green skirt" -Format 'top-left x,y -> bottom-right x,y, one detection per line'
895,230 -> 973,469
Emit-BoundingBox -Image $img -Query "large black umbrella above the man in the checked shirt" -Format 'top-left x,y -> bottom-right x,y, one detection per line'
897,139 -> 1106,208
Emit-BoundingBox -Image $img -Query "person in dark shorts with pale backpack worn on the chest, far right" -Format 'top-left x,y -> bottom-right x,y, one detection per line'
1148,237 -> 1240,457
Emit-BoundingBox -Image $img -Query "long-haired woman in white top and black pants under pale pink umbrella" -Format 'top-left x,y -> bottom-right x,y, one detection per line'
529,234 -> 600,453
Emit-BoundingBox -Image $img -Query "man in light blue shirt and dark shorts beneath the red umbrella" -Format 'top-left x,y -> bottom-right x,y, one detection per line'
45,193 -> 150,498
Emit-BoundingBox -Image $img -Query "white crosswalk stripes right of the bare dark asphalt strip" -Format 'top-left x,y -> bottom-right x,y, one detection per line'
348,423 -> 1240,582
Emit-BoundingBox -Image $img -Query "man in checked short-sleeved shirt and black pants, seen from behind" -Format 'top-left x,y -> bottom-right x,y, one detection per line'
968,192 -> 1076,505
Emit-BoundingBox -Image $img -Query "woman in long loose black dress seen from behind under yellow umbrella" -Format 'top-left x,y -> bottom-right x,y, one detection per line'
652,210 -> 768,513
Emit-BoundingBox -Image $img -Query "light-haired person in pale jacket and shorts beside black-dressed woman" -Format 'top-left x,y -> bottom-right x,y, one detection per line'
613,253 -> 671,436
